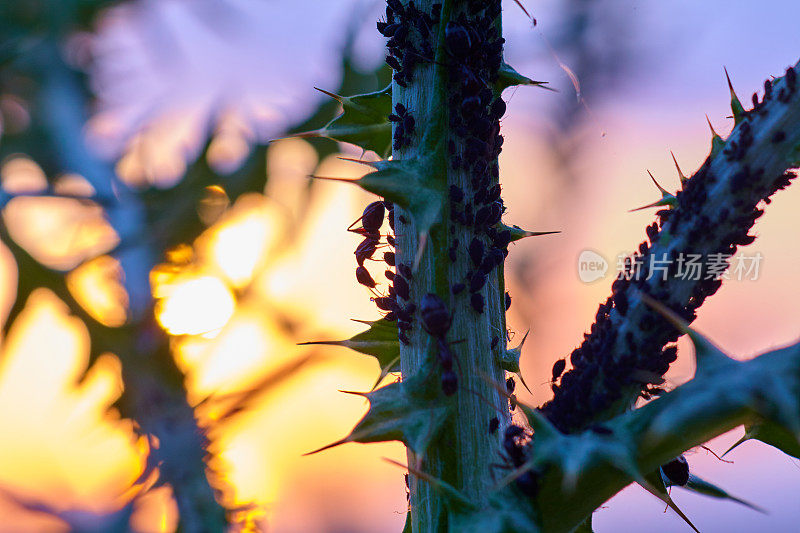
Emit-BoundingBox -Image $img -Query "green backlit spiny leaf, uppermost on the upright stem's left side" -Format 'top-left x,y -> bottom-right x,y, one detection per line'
297,85 -> 392,157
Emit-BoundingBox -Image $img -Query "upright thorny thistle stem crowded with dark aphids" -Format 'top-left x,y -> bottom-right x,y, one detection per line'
387,0 -> 510,532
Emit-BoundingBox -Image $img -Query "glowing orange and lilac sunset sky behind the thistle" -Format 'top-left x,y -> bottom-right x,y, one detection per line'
0,0 -> 800,533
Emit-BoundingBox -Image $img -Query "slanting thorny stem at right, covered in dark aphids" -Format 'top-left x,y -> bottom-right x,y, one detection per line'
542,58 -> 800,432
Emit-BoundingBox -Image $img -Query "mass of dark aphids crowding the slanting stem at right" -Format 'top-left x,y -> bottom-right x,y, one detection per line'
542,64 -> 797,432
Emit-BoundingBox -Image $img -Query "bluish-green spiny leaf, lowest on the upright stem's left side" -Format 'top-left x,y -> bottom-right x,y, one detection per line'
306,369 -> 451,456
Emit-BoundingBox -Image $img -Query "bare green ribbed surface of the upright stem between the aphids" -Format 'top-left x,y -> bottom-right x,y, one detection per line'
392,0 -> 509,532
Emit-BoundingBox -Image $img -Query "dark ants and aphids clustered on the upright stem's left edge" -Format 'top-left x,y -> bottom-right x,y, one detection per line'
347,200 -> 416,344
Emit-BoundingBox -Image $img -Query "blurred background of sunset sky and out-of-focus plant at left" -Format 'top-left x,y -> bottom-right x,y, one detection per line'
0,0 -> 800,531
